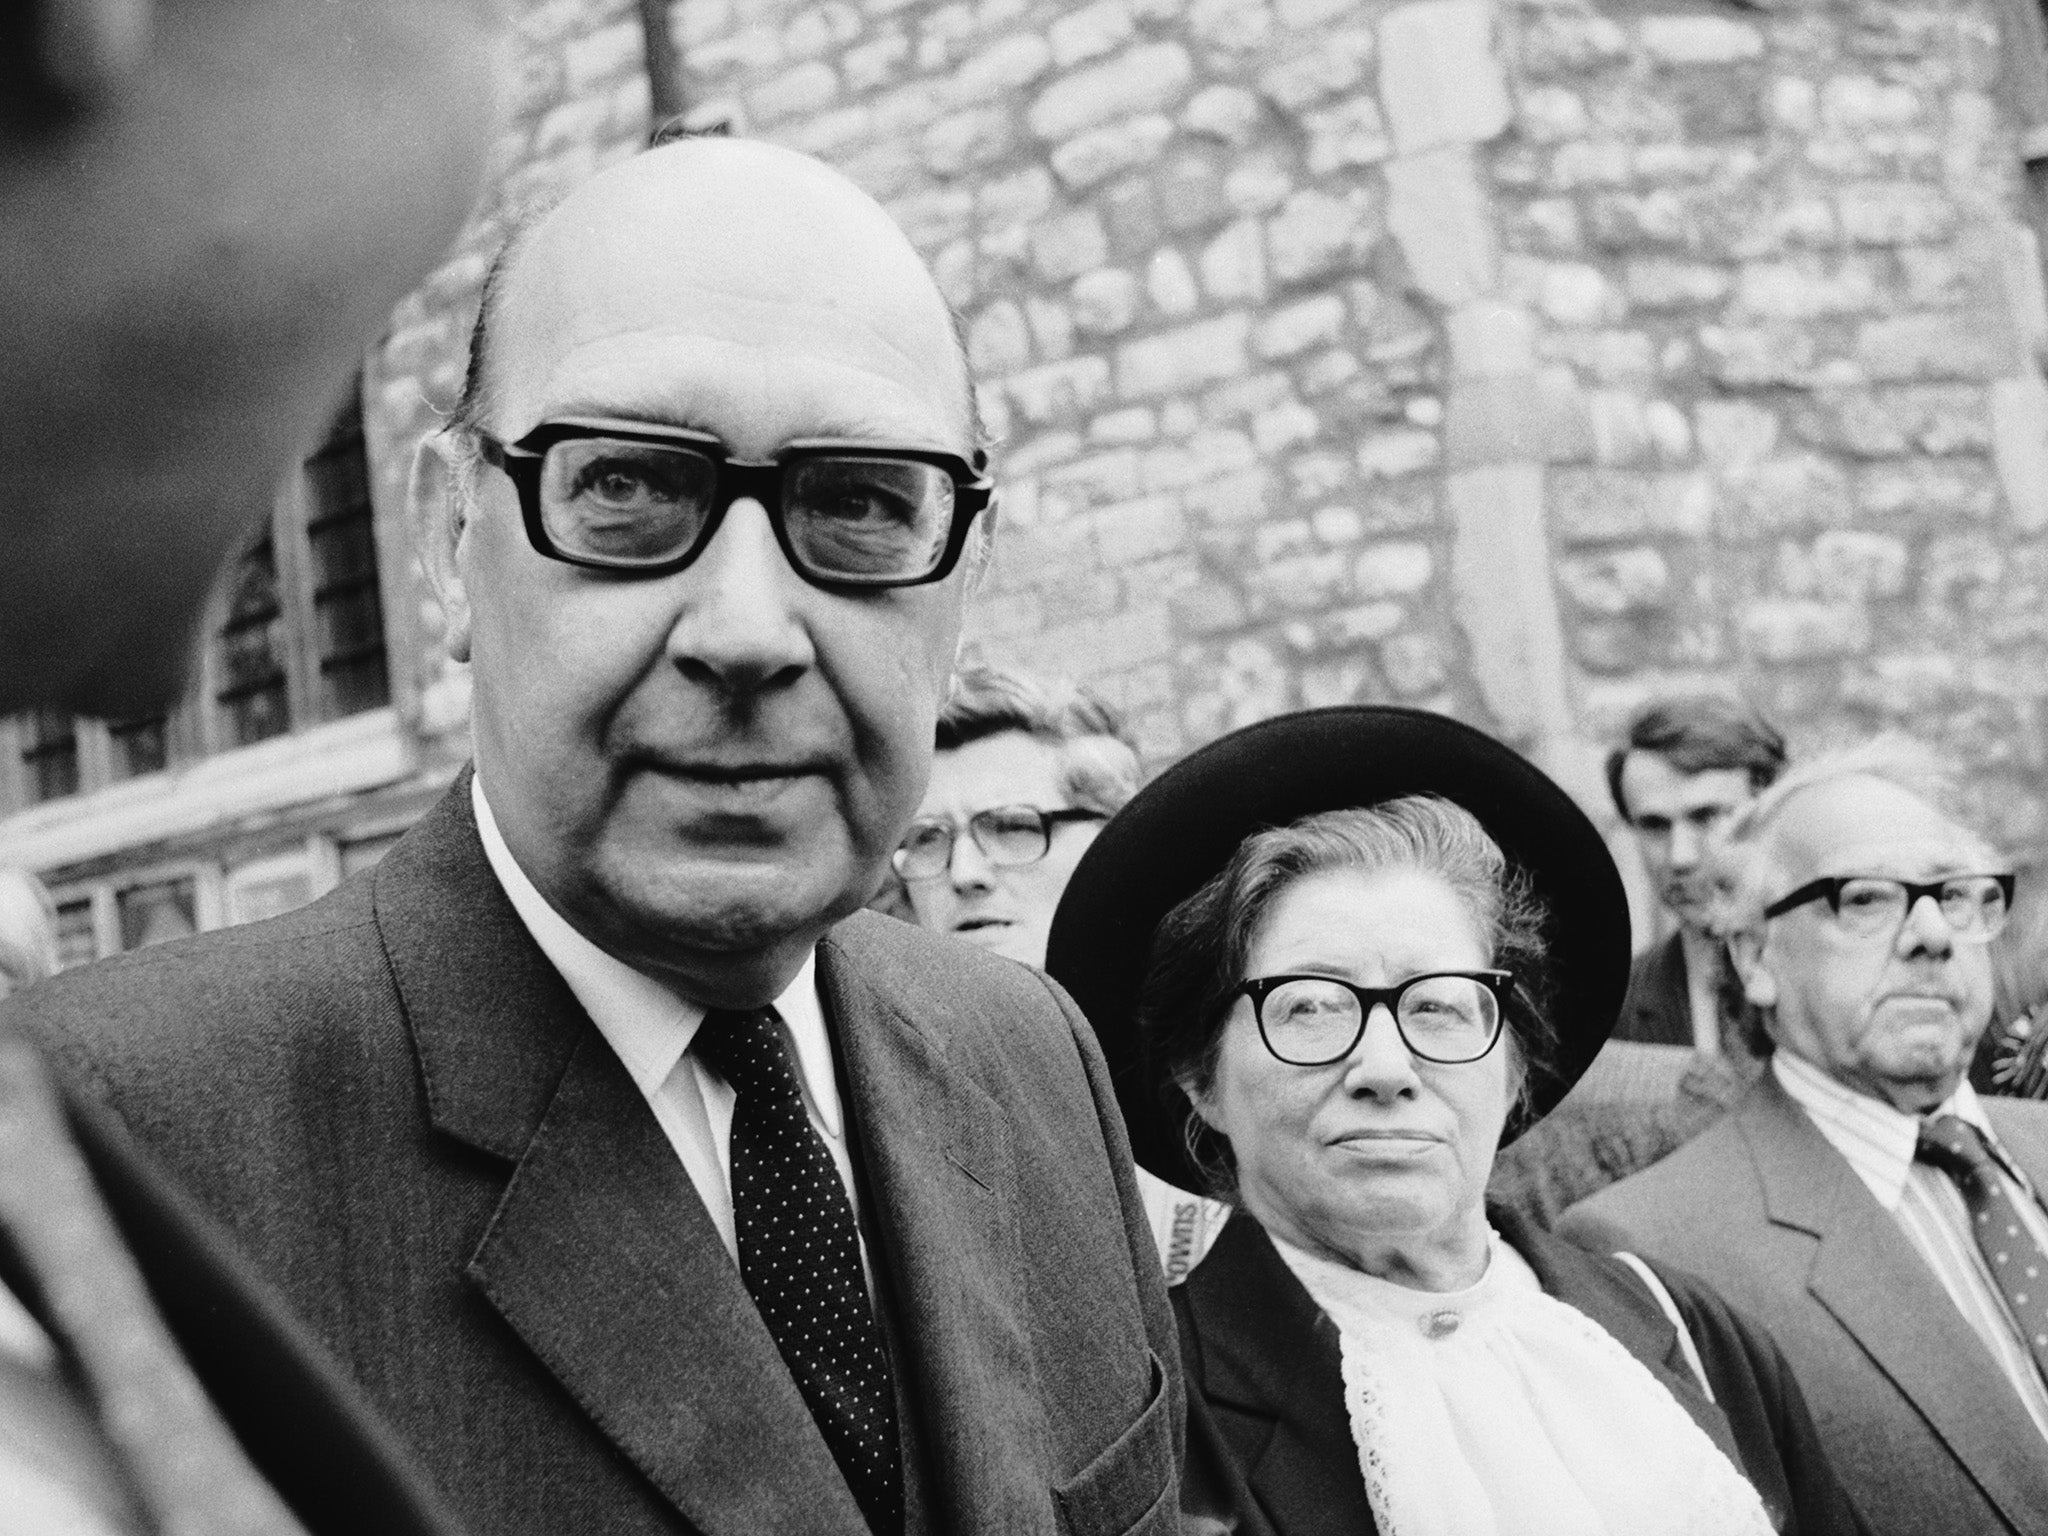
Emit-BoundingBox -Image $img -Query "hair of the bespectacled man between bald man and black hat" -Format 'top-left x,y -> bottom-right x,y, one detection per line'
938,662 -> 1141,815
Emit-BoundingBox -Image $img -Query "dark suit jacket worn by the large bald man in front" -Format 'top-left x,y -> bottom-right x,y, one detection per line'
16,774 -> 1182,1536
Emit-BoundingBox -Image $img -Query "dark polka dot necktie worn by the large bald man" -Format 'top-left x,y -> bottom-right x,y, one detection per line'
692,1010 -> 903,1536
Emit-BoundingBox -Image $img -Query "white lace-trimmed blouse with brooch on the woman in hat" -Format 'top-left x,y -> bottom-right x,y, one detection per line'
1274,1231 -> 1772,1536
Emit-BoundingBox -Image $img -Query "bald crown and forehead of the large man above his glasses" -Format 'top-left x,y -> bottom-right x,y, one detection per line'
492,141 -> 963,432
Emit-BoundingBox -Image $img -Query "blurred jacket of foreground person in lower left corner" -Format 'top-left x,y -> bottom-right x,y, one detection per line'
0,1026 -> 455,1536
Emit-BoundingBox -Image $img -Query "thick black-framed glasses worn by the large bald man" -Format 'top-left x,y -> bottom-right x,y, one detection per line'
475,418 -> 993,592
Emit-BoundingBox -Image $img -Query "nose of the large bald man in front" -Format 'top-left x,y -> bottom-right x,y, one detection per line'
668,498 -> 817,694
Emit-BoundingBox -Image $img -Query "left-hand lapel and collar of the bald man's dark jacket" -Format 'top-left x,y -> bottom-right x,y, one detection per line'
377,784 -> 864,1536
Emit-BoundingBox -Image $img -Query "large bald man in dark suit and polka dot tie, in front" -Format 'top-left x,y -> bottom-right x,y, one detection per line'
23,139 -> 1182,1536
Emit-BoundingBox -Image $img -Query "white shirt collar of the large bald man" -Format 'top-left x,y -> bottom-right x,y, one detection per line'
469,774 -> 842,1139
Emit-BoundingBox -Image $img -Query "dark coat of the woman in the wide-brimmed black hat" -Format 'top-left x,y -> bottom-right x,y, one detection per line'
1174,1210 -> 1862,1536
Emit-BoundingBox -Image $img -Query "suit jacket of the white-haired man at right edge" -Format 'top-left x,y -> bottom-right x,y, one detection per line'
1559,1073 -> 2048,1536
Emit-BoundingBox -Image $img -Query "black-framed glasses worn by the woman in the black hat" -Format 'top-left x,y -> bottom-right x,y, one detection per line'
1239,971 -> 1513,1067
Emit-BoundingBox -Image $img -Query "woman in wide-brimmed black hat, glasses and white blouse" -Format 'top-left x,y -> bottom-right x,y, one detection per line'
1049,707 -> 1858,1536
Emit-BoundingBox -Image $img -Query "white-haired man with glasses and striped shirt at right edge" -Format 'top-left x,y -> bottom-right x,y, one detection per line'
1563,741 -> 2048,1536
